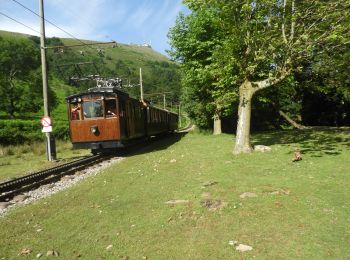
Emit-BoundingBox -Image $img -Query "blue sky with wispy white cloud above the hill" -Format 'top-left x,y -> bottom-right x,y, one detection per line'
0,0 -> 188,55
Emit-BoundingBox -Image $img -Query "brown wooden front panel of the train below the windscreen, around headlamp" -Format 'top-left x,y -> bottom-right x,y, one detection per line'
70,118 -> 120,143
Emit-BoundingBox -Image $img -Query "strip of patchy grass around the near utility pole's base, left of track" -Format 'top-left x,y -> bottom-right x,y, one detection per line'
0,140 -> 90,182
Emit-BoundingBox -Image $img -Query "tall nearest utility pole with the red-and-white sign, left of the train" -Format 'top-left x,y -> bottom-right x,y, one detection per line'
39,0 -> 56,161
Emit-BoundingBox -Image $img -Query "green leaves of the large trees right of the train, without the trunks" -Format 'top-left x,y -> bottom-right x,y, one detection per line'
170,0 -> 350,130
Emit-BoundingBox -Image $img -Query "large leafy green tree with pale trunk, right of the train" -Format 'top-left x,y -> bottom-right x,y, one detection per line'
170,0 -> 350,153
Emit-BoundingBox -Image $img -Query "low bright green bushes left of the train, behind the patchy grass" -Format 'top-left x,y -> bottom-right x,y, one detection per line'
0,119 -> 69,145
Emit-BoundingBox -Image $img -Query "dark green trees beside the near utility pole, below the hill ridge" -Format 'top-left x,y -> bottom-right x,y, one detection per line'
0,37 -> 56,118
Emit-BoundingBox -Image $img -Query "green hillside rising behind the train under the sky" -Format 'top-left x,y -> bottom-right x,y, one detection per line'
0,31 -> 180,120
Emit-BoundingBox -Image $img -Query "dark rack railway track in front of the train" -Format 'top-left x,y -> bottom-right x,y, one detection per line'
0,154 -> 108,202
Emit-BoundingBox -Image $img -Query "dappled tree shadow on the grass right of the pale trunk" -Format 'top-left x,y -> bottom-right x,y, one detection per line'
252,127 -> 350,157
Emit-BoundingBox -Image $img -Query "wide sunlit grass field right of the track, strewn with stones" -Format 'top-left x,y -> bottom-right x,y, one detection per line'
0,129 -> 350,259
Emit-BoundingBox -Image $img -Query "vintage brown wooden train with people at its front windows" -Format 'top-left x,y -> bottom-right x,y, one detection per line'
66,86 -> 178,154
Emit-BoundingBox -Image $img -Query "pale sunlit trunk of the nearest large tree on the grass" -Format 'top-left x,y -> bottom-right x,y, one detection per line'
233,80 -> 255,154
